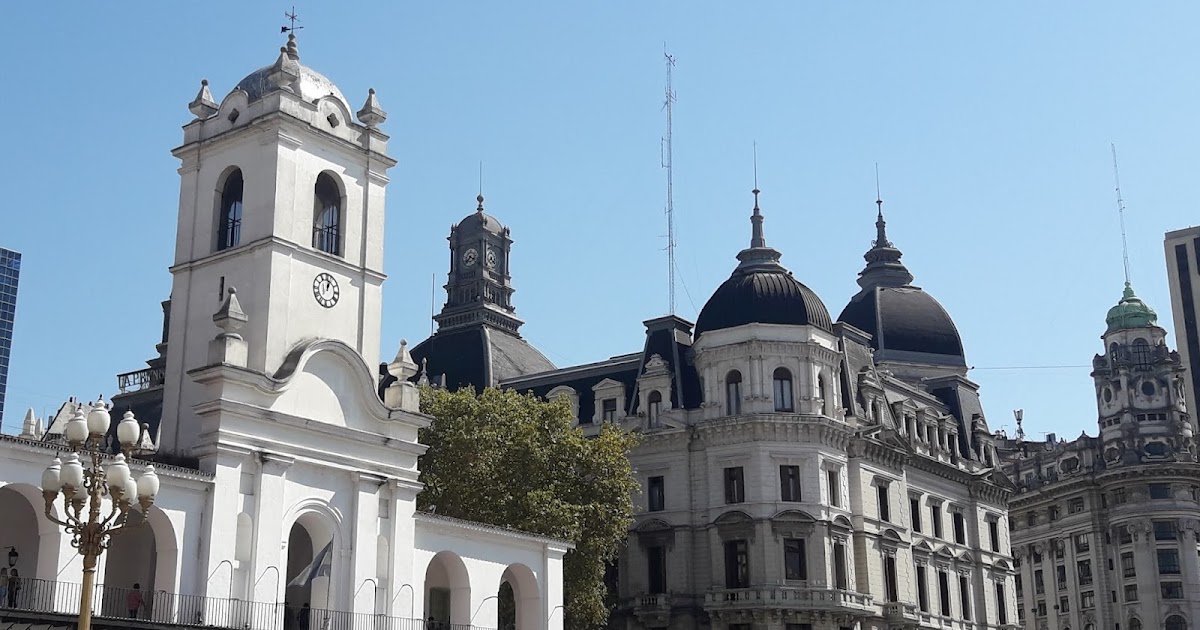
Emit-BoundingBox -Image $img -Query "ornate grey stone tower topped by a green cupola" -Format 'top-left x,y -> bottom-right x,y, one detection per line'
1092,282 -> 1196,467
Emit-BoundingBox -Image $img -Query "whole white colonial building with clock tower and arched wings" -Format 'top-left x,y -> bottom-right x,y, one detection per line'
0,31 -> 571,630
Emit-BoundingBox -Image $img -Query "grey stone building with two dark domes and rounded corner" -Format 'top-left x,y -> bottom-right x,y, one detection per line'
502,190 -> 1016,630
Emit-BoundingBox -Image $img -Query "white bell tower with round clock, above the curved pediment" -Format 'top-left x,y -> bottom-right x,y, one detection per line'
160,34 -> 396,454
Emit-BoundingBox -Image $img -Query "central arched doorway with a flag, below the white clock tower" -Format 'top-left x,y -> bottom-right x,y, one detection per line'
283,512 -> 335,630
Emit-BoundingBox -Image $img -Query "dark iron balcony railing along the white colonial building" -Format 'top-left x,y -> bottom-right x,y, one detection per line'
0,580 -> 484,630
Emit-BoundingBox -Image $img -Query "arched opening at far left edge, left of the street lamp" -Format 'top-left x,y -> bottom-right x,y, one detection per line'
0,484 -> 61,607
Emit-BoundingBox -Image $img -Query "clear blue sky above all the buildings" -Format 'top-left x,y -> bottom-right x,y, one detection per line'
0,0 -> 1200,437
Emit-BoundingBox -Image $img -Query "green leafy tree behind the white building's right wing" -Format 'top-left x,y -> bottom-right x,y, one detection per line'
416,388 -> 638,630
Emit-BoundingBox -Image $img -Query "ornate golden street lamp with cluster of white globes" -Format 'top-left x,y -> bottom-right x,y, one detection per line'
39,398 -> 158,630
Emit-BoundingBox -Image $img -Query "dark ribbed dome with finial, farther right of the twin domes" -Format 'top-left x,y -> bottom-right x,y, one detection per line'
838,198 -> 966,366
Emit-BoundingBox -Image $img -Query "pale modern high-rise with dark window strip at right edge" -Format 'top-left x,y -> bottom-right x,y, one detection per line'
1164,227 -> 1200,429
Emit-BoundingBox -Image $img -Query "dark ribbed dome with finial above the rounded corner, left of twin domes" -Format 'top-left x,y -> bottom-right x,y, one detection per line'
696,188 -> 833,337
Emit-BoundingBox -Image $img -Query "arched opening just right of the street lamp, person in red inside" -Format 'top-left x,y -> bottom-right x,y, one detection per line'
100,510 -> 158,619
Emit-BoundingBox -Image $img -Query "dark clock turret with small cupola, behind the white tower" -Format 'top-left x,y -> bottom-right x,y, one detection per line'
434,194 -> 523,334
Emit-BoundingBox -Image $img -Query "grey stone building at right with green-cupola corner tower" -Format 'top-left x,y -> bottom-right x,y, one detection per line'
998,283 -> 1200,630
